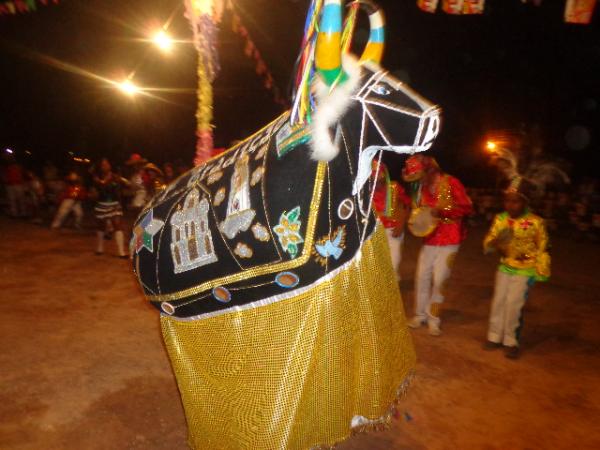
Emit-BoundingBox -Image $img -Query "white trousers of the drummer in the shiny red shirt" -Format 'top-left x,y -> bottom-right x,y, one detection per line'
415,244 -> 460,325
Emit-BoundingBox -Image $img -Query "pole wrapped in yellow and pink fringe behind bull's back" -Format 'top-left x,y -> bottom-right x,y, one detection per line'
184,0 -> 223,165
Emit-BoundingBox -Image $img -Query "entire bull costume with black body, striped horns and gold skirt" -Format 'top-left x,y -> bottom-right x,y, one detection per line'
131,0 -> 439,449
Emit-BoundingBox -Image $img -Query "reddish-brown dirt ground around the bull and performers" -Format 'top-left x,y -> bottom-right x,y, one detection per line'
0,218 -> 600,450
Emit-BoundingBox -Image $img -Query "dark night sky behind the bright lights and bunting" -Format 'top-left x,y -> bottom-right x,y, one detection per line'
0,0 -> 600,183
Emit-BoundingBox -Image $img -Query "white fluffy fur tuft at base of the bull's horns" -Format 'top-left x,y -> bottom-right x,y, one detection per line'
311,55 -> 361,161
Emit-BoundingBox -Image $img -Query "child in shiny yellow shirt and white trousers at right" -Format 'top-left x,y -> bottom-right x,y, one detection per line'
483,178 -> 550,359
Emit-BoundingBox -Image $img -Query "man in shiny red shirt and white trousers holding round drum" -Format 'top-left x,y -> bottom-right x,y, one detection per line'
402,155 -> 473,336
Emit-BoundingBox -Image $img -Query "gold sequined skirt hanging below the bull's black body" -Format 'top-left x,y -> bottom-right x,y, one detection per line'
161,227 -> 415,450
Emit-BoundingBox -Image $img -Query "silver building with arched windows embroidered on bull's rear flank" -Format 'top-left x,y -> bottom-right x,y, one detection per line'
170,189 -> 218,273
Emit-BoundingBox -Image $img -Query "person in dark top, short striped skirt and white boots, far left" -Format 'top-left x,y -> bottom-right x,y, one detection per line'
92,158 -> 129,259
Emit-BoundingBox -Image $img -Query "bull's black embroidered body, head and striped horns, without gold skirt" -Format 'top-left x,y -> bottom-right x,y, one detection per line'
131,0 -> 439,320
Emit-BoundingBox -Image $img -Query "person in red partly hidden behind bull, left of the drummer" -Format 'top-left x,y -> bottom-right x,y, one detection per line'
372,161 -> 410,281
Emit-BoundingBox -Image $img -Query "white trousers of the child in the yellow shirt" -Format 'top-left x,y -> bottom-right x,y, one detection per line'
488,271 -> 530,347
